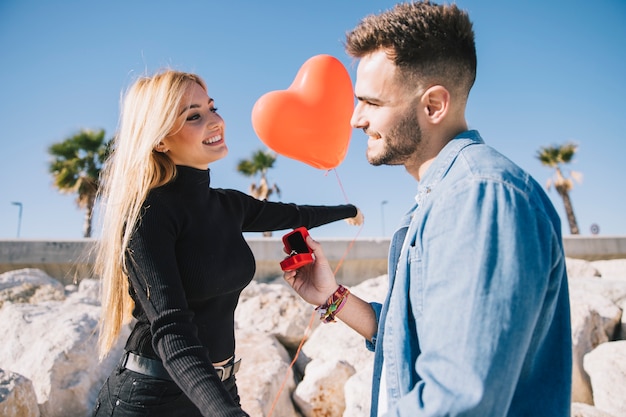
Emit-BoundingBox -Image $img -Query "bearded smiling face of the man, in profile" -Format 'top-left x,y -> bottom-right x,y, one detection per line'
351,51 -> 422,165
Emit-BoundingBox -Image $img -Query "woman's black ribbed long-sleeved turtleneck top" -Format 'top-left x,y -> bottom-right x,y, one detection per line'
126,166 -> 357,416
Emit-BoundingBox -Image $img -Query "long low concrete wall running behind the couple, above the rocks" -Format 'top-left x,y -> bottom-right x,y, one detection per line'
0,236 -> 626,285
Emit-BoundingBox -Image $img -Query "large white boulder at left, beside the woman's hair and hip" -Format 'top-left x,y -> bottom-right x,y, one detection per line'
0,299 -> 128,417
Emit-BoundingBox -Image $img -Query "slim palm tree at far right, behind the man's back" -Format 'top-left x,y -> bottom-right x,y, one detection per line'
536,142 -> 582,235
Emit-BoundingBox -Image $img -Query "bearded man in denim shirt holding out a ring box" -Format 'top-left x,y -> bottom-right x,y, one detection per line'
285,2 -> 572,417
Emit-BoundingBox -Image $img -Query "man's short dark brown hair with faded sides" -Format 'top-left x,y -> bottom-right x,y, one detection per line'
345,0 -> 476,98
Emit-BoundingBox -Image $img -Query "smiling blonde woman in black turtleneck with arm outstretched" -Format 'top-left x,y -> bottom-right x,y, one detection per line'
94,70 -> 362,417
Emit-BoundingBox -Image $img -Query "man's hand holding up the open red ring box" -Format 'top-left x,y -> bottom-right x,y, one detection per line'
283,236 -> 338,305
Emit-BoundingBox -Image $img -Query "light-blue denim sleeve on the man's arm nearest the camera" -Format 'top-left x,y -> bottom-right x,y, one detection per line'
386,179 -> 554,417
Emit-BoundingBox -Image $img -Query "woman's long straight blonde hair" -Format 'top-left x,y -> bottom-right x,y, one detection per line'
94,70 -> 206,358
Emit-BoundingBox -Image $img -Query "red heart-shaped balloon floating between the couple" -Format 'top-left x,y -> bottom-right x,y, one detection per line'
252,55 -> 354,169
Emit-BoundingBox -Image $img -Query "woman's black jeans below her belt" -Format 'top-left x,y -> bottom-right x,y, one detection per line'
93,358 -> 240,417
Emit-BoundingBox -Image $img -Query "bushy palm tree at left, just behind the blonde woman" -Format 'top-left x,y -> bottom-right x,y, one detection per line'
48,129 -> 112,237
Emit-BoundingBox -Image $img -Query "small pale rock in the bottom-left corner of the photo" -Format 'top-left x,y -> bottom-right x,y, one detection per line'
0,369 -> 40,417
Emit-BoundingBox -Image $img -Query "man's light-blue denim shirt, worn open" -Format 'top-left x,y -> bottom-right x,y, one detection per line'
367,131 -> 572,417
